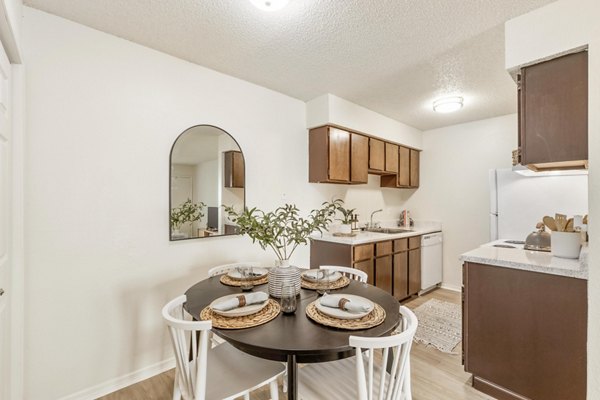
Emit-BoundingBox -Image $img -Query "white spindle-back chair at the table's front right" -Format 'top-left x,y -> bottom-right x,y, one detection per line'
298,306 -> 418,400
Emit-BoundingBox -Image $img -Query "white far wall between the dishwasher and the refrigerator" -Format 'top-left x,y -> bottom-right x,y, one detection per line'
406,114 -> 517,289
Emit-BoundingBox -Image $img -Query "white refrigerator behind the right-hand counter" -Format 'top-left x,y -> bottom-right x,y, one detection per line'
489,169 -> 588,241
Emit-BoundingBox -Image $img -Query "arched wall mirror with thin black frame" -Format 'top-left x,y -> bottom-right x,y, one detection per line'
169,125 -> 246,240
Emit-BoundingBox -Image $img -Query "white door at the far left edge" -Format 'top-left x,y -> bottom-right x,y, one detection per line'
0,38 -> 12,399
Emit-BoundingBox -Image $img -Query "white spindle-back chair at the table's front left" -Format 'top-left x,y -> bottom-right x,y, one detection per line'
162,295 -> 285,400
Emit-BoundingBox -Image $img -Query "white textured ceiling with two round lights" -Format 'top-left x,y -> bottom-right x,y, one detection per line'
25,0 -> 552,129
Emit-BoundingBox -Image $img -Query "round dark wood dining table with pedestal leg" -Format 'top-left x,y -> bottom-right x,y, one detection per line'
184,275 -> 400,399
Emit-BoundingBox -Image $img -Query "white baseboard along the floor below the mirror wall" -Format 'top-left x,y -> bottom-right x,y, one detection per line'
60,358 -> 175,400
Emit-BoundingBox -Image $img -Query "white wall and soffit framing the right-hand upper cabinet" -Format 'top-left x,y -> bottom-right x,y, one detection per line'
505,0 -> 600,399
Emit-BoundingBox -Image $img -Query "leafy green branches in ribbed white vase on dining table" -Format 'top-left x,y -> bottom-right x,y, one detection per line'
224,200 -> 342,297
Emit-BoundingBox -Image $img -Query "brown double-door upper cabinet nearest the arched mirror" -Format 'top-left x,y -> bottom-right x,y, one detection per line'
308,126 -> 369,184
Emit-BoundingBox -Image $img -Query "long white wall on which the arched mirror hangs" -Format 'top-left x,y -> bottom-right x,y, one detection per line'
23,8 -> 414,400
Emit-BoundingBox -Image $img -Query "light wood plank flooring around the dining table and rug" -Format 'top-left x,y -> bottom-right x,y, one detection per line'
101,289 -> 492,400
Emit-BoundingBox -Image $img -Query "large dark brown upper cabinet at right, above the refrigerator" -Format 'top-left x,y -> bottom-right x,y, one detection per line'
518,51 -> 588,171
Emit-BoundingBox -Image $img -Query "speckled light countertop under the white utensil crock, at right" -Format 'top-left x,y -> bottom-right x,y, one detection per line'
460,245 -> 588,280
